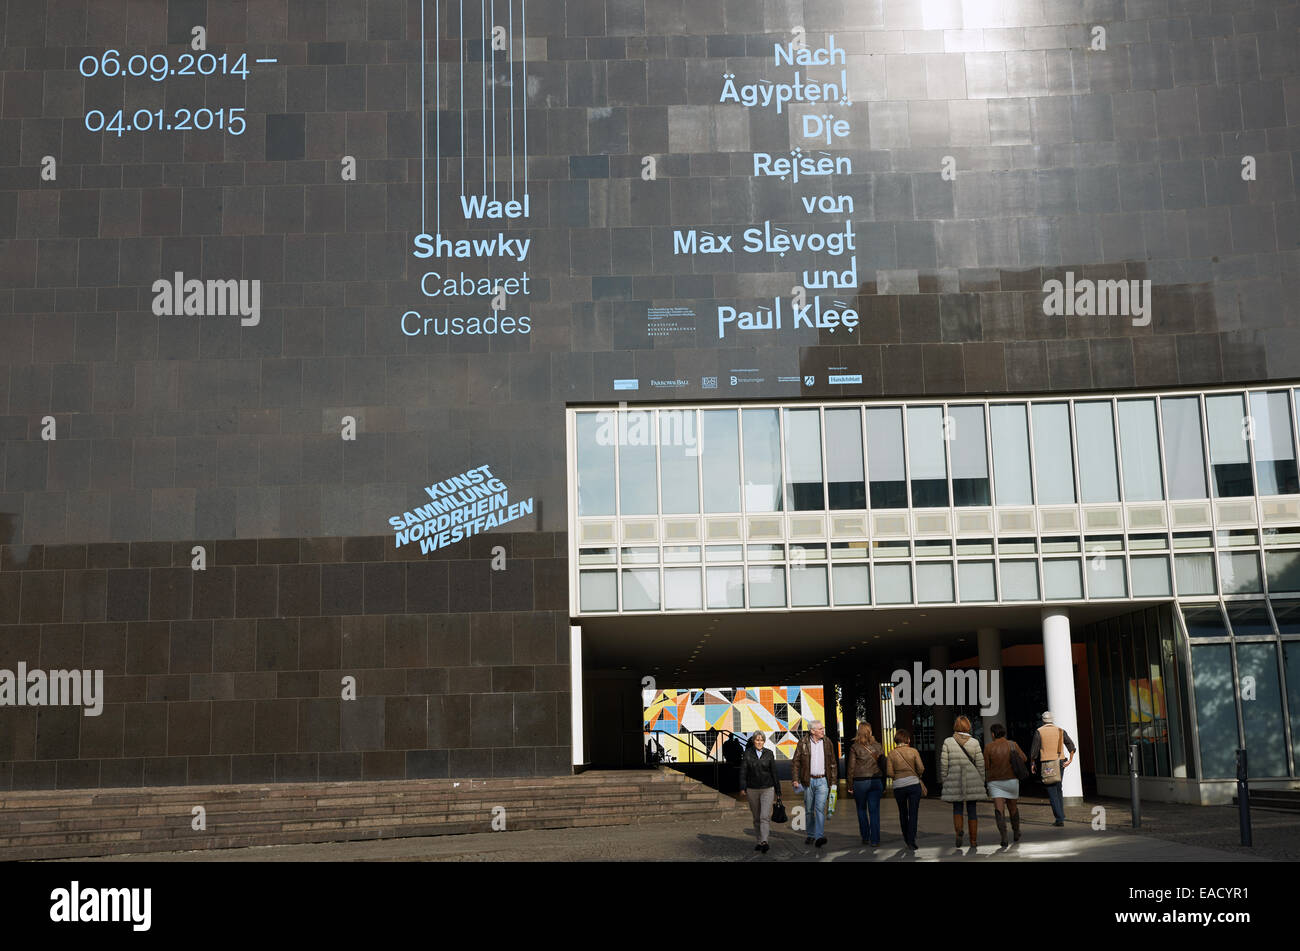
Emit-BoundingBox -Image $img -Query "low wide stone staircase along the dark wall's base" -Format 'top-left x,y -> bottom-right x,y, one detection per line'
0,769 -> 749,861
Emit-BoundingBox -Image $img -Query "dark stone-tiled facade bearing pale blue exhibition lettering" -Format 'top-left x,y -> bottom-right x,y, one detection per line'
0,0 -> 1300,787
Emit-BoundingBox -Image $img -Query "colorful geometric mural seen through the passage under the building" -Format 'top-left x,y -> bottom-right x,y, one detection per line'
641,686 -> 826,763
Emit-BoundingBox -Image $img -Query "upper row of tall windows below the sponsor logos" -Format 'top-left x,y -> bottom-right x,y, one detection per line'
575,390 -> 1300,517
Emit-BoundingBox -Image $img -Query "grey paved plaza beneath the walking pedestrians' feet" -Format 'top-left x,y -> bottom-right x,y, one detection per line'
65,799 -> 1300,863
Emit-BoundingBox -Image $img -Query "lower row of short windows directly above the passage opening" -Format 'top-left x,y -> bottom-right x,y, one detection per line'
579,546 -> 1300,613
